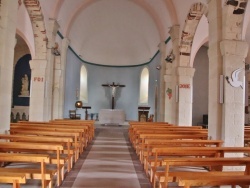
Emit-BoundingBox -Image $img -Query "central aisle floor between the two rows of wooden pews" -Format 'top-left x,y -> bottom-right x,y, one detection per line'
60,125 -> 151,188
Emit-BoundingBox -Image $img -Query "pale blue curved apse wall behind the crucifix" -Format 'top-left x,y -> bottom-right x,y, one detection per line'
64,49 -> 160,120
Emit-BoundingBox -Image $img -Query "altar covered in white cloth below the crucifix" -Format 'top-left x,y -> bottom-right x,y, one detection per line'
99,109 -> 125,124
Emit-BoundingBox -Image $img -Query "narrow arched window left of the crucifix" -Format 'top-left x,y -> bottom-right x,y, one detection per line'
80,65 -> 88,103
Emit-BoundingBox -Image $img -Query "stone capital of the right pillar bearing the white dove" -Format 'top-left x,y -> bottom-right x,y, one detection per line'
220,40 -> 248,58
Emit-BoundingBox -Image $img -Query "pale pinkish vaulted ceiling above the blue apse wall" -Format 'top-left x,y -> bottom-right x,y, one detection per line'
24,0 -> 249,66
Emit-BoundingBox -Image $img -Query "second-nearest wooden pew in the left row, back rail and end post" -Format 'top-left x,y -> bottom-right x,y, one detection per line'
0,153 -> 51,188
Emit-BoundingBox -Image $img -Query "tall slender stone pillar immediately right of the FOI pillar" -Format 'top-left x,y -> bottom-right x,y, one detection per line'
44,19 -> 59,121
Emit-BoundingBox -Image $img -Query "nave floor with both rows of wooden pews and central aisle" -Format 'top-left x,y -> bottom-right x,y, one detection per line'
0,120 -> 250,188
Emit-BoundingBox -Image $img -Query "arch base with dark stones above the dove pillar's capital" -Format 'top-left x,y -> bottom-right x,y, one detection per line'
223,0 -> 247,40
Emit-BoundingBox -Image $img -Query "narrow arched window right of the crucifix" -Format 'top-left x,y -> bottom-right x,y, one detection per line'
139,67 -> 149,104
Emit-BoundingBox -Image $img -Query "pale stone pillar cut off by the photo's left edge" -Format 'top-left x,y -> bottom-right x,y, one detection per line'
0,0 -> 18,133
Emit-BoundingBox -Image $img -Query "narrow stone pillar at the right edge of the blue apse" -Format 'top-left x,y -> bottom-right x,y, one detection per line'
158,41 -> 166,122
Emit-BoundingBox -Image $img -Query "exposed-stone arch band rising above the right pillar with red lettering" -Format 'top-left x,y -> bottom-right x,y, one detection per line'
180,3 -> 207,66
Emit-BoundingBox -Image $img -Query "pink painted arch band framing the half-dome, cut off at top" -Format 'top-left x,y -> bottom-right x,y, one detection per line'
63,0 -> 165,40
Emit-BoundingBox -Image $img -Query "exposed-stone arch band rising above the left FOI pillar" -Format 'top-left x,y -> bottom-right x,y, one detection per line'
24,0 -> 47,59
